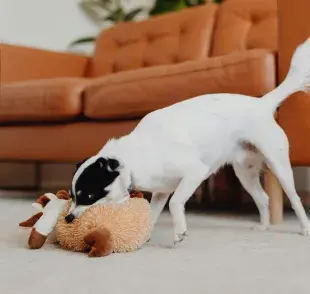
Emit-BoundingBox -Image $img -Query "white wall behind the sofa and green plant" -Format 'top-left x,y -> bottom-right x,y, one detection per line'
0,0 -> 153,51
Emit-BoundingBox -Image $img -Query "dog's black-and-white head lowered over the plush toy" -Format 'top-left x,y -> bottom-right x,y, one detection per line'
66,157 -> 130,222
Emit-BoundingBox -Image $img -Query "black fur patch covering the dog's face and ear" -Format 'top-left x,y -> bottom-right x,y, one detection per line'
73,158 -> 120,205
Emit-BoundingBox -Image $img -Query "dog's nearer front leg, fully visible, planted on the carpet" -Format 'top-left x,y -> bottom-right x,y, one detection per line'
169,162 -> 210,244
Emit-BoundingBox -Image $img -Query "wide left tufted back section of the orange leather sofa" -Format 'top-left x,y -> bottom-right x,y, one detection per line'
88,4 -> 217,77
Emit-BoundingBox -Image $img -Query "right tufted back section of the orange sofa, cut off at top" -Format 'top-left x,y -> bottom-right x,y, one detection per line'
211,0 -> 278,56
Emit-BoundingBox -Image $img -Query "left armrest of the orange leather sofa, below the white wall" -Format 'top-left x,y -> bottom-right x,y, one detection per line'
0,44 -> 88,82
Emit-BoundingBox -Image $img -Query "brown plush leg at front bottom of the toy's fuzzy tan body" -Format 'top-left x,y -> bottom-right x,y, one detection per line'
84,228 -> 113,257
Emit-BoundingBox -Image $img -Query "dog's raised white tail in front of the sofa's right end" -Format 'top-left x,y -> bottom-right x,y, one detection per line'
262,37 -> 310,112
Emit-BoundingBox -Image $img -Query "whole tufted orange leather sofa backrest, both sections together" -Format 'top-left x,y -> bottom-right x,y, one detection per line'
87,0 -> 278,77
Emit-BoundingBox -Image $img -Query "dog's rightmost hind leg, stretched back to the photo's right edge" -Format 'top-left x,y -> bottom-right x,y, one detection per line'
252,123 -> 310,235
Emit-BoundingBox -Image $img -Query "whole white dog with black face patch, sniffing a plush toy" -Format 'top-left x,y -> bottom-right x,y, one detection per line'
67,38 -> 310,243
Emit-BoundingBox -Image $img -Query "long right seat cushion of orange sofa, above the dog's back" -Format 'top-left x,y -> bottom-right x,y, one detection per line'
85,49 -> 275,119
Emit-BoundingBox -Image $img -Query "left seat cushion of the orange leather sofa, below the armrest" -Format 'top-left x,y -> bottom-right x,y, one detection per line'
0,78 -> 87,123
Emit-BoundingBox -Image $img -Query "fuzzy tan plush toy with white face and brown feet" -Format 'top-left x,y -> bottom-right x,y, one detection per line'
19,190 -> 152,257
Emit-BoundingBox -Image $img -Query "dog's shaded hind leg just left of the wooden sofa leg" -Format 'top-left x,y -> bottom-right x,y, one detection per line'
233,158 -> 270,231
